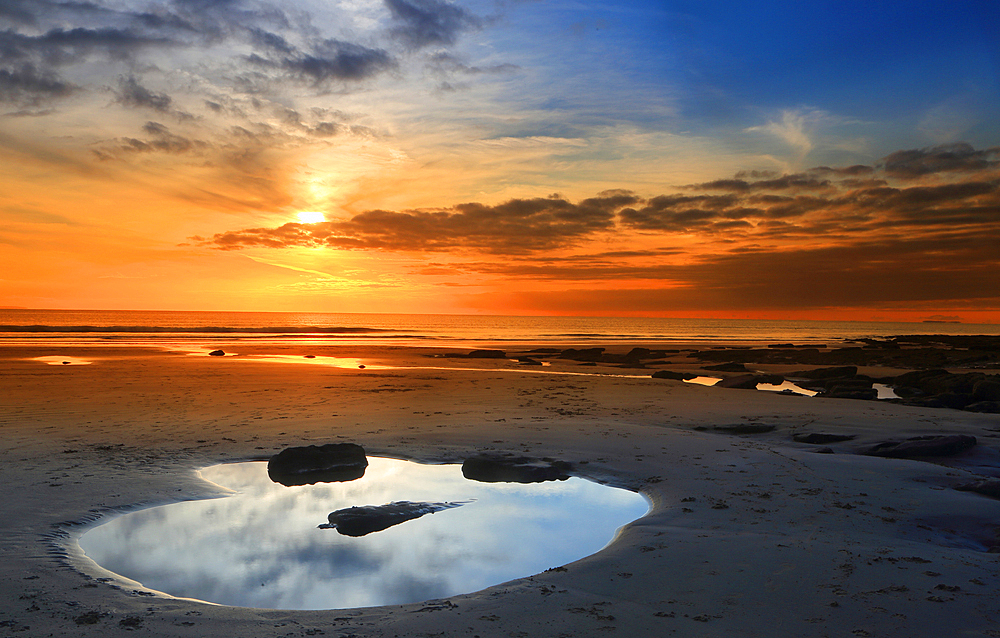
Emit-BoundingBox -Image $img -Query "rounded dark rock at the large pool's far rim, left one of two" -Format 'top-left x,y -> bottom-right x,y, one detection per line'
267,443 -> 368,486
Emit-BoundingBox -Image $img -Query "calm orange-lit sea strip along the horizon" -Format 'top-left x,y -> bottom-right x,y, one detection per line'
0,309 -> 1000,345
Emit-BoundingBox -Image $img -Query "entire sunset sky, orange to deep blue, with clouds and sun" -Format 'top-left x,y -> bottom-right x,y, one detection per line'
0,0 -> 1000,323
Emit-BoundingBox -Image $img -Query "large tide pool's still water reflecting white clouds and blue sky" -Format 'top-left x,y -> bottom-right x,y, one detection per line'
80,457 -> 648,609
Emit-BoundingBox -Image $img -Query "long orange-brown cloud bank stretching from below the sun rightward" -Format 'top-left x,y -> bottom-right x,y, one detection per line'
195,147 -> 1000,313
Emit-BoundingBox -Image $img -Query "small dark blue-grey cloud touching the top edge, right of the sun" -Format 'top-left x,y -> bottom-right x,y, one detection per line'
384,0 -> 482,49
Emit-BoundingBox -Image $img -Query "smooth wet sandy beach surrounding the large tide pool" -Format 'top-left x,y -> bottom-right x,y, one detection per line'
0,347 -> 1000,638
